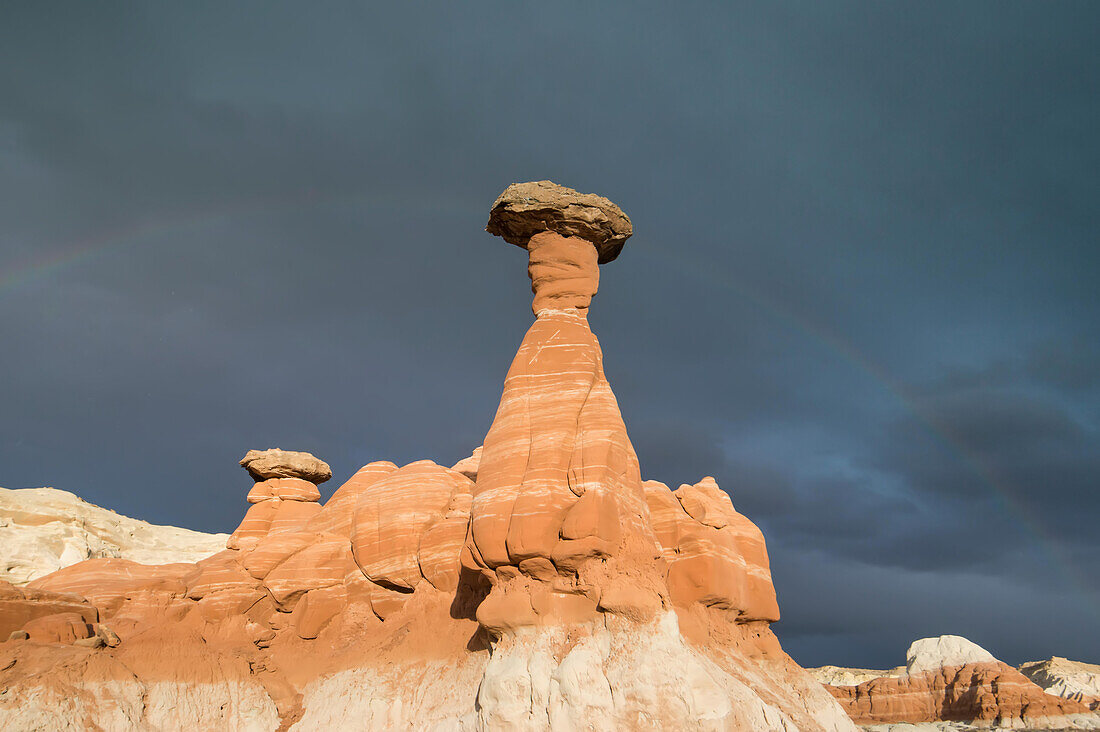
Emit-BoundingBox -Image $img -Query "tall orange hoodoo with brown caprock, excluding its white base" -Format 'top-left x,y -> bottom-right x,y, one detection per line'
465,182 -> 667,632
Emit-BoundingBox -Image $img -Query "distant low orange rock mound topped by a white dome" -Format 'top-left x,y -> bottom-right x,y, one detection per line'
827,635 -> 1100,730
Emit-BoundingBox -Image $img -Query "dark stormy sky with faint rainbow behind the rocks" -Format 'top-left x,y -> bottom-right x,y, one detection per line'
0,2 -> 1100,667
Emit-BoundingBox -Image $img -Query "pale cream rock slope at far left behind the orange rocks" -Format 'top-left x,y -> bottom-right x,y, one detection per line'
0,488 -> 227,581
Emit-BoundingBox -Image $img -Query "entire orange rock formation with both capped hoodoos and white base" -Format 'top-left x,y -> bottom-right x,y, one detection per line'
0,182 -> 855,731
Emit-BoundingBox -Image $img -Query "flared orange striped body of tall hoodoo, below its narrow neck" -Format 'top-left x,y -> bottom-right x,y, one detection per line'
465,295 -> 666,630
